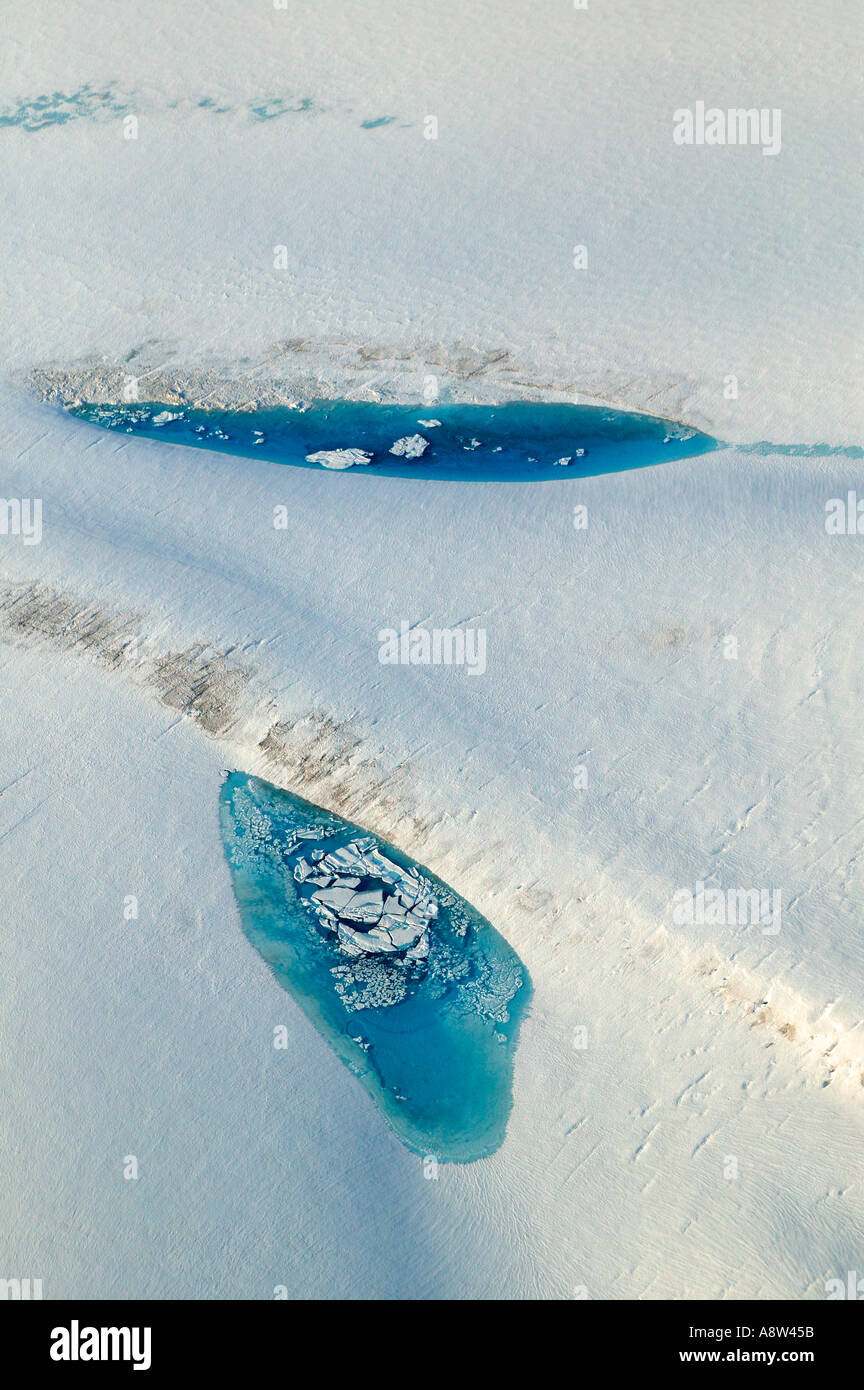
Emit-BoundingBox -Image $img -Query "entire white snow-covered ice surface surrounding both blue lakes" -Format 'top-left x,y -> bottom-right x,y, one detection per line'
0,0 -> 864,1298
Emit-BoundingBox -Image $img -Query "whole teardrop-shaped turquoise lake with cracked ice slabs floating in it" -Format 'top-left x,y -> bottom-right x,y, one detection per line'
221,773 -> 531,1162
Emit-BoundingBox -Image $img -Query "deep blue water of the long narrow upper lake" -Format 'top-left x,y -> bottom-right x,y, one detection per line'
72,400 -> 718,481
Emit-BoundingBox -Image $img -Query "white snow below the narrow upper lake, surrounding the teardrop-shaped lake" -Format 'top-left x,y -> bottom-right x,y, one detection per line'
0,378 -> 864,1297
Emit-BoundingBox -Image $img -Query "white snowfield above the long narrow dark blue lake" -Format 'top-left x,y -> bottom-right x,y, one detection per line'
0,0 -> 864,443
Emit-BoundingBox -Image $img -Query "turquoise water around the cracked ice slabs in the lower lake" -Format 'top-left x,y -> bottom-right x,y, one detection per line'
221,773 -> 531,1162
